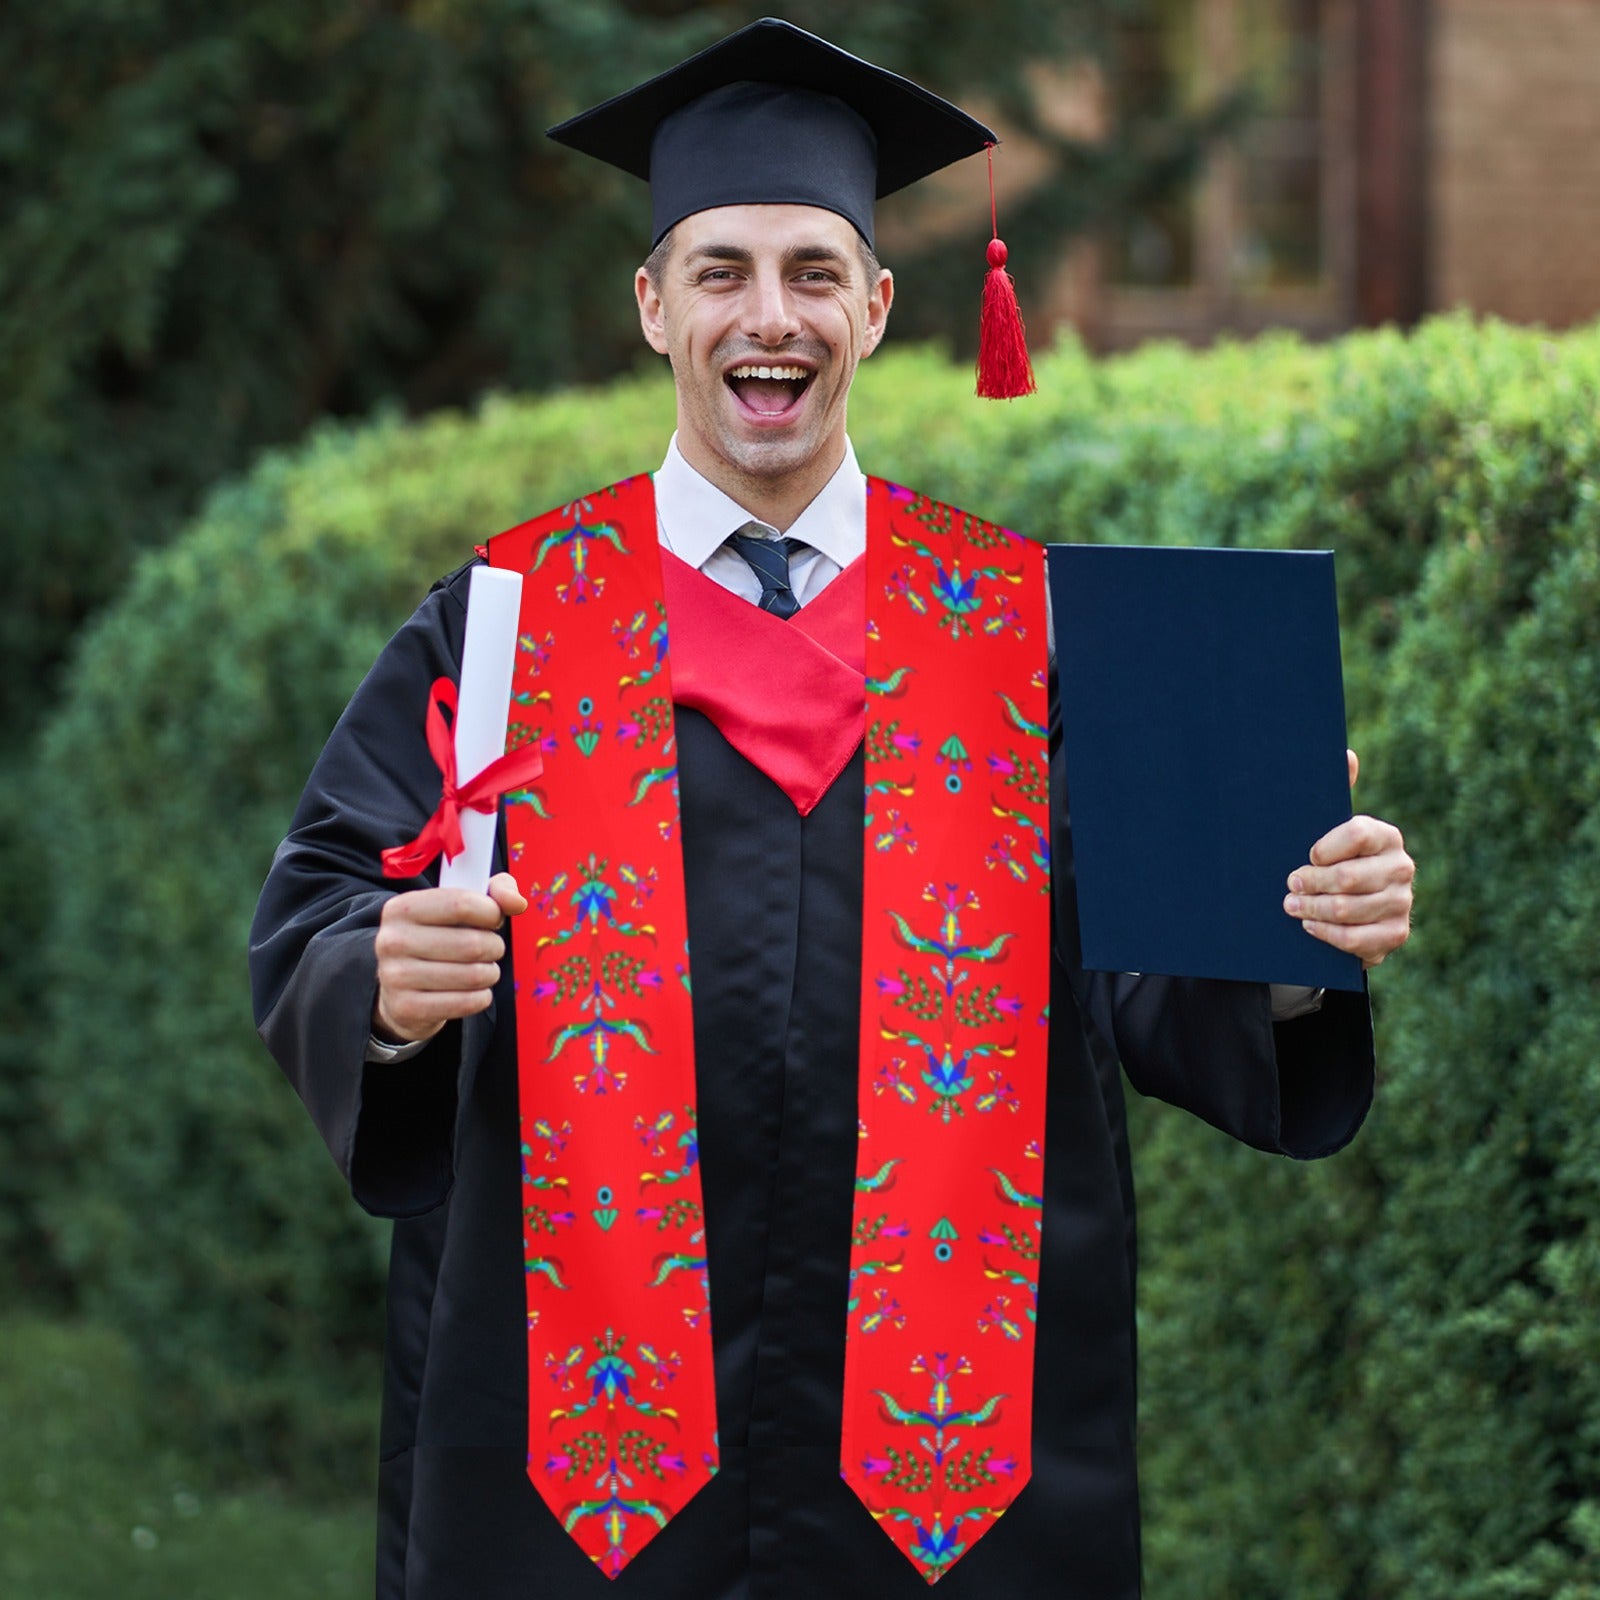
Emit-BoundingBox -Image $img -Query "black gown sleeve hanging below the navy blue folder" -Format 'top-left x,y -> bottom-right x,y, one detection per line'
1050,674 -> 1374,1160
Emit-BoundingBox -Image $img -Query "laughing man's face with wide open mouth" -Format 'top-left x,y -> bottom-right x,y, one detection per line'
635,205 -> 894,488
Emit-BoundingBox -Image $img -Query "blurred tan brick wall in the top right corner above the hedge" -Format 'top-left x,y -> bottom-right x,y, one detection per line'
1429,0 -> 1600,326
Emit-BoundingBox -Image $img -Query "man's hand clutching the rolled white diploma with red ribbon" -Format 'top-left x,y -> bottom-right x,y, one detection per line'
373,872 -> 528,1043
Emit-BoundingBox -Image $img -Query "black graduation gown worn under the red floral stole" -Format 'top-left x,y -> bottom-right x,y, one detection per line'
251,556 -> 1373,1600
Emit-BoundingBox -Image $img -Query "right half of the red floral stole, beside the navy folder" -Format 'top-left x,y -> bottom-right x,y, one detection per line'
840,480 -> 1050,1582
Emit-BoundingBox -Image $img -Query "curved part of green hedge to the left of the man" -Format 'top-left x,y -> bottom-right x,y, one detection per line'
42,374 -> 670,1480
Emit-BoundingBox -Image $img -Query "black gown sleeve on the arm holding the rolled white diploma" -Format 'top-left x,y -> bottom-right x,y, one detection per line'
250,566 -> 493,1218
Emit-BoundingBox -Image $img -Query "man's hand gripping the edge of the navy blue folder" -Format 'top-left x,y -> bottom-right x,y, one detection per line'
1283,750 -> 1416,966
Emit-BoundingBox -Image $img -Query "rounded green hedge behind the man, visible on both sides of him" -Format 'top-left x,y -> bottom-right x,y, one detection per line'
31,320 -> 1600,1600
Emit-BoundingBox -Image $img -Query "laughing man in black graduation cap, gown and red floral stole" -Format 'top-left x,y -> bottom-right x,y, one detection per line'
251,21 -> 1411,1600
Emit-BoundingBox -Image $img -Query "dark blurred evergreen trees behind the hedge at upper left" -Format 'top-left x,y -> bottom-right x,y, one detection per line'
0,0 -> 1203,752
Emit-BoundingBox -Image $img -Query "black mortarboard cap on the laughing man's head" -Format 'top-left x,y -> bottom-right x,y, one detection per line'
550,18 -> 997,245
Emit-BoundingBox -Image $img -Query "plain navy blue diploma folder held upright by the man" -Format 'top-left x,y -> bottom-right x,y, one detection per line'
1048,544 -> 1362,989
